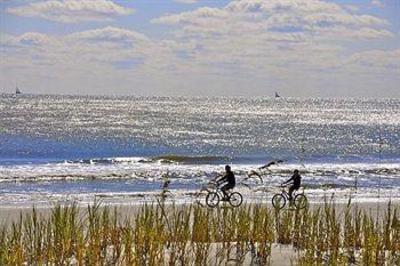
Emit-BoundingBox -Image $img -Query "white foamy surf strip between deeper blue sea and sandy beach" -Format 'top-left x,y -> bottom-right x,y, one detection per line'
0,157 -> 400,207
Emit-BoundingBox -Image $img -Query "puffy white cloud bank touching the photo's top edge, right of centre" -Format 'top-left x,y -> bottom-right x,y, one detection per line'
152,0 -> 388,38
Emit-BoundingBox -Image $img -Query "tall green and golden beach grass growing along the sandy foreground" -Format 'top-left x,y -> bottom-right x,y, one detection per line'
0,201 -> 400,265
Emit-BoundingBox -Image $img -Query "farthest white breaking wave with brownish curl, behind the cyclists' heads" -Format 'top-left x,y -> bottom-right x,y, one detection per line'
0,155 -> 400,186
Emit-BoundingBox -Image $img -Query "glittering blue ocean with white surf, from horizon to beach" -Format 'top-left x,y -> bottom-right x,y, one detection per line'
0,95 -> 400,206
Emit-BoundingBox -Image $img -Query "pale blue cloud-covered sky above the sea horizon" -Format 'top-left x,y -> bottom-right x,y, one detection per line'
0,0 -> 400,98
